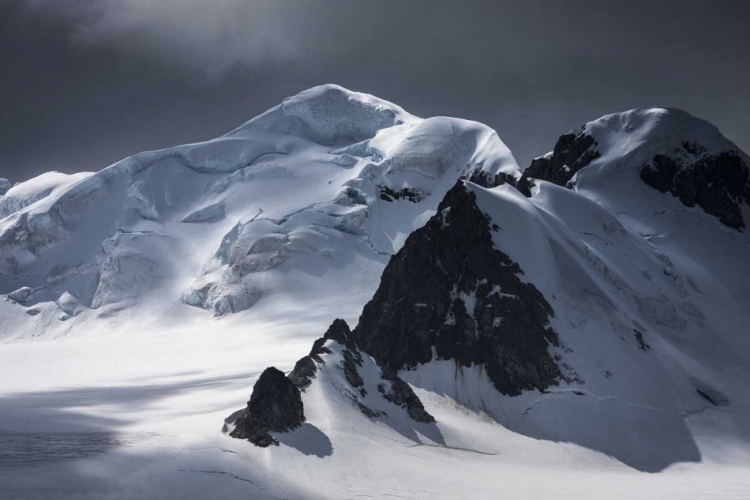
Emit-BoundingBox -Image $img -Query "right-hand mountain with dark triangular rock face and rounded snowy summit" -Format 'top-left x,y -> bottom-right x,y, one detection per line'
226,104 -> 750,488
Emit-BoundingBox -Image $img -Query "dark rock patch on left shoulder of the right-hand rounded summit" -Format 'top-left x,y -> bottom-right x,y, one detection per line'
523,132 -> 601,186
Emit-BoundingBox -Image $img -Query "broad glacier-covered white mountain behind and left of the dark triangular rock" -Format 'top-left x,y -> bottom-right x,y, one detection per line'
0,85 -> 520,338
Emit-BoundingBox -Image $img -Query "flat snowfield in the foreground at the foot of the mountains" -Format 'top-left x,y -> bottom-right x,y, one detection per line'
0,321 -> 750,499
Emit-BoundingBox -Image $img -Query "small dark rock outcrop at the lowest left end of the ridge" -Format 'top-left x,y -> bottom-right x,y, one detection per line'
230,367 -> 305,447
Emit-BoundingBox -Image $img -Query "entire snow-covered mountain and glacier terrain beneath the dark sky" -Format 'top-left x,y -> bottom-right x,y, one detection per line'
0,85 -> 750,499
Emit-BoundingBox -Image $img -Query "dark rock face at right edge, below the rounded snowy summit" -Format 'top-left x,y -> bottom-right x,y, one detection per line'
641,142 -> 750,229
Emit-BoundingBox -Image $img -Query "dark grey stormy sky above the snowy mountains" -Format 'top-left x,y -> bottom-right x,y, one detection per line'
0,0 -> 750,182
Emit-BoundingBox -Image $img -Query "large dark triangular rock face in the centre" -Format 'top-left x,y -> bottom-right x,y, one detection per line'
353,181 -> 563,395
